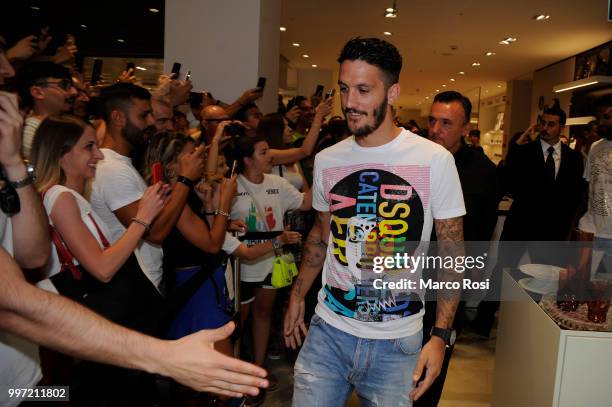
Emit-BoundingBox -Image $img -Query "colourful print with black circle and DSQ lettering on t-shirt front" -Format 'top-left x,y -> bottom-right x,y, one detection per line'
322,164 -> 429,322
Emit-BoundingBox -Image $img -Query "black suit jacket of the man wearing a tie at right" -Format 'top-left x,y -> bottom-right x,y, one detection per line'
501,139 -> 584,241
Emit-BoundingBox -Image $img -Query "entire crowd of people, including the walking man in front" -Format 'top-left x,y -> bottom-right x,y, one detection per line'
0,26 -> 612,406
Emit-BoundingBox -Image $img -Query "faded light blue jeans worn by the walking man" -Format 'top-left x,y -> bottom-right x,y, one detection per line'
293,315 -> 423,407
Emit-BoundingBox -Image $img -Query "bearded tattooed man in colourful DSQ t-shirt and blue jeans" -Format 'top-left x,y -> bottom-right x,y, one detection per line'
284,38 -> 465,407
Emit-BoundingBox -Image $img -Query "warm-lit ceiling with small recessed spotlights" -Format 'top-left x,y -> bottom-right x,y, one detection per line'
281,0 -> 612,108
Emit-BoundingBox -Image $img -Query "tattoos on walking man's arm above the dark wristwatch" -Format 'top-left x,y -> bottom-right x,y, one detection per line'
435,217 -> 465,328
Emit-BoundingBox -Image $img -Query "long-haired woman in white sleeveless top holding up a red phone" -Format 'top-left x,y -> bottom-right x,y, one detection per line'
31,116 -> 168,401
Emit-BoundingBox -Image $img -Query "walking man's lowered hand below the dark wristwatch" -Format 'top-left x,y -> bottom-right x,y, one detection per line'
410,336 -> 446,400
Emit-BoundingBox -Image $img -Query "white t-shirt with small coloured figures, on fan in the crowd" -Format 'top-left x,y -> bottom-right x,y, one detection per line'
230,174 -> 304,282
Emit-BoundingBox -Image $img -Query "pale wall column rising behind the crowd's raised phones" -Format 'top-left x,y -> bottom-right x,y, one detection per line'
165,0 -> 280,111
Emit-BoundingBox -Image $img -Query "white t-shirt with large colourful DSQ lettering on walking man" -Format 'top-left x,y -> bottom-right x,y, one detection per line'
313,130 -> 465,339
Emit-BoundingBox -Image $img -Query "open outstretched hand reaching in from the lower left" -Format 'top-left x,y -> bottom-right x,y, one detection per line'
161,322 -> 268,397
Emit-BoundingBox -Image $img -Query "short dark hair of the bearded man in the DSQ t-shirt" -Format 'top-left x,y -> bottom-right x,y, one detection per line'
338,37 -> 402,87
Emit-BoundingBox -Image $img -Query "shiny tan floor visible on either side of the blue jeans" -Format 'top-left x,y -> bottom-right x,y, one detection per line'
263,324 -> 495,407
